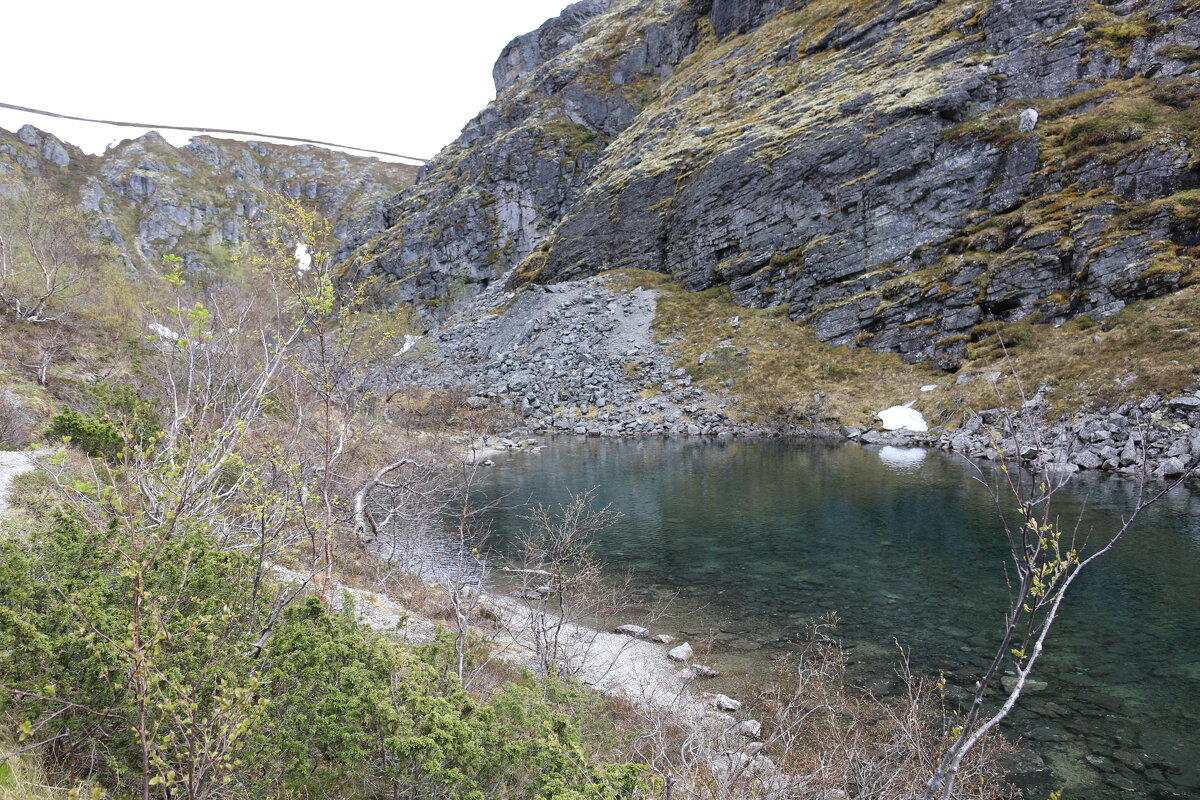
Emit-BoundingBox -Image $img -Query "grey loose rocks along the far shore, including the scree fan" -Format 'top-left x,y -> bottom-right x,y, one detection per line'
381,276 -> 1200,480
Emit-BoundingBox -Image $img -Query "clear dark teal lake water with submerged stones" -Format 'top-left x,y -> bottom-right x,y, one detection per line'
472,439 -> 1200,799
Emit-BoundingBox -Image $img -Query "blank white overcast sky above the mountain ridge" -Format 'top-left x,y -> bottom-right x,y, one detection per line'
0,0 -> 570,164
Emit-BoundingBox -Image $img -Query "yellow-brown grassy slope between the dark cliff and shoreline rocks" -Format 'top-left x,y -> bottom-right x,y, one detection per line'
610,270 -> 1200,426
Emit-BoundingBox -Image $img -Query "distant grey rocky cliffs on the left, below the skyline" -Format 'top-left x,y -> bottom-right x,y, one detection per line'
0,125 -> 416,284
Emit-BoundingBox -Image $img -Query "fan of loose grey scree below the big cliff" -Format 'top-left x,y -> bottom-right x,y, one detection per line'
373,277 -> 760,438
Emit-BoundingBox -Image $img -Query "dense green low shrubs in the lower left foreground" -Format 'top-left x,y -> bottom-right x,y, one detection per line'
0,513 -> 646,800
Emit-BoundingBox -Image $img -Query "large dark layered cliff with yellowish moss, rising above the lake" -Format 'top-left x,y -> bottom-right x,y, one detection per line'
348,0 -> 1200,368
